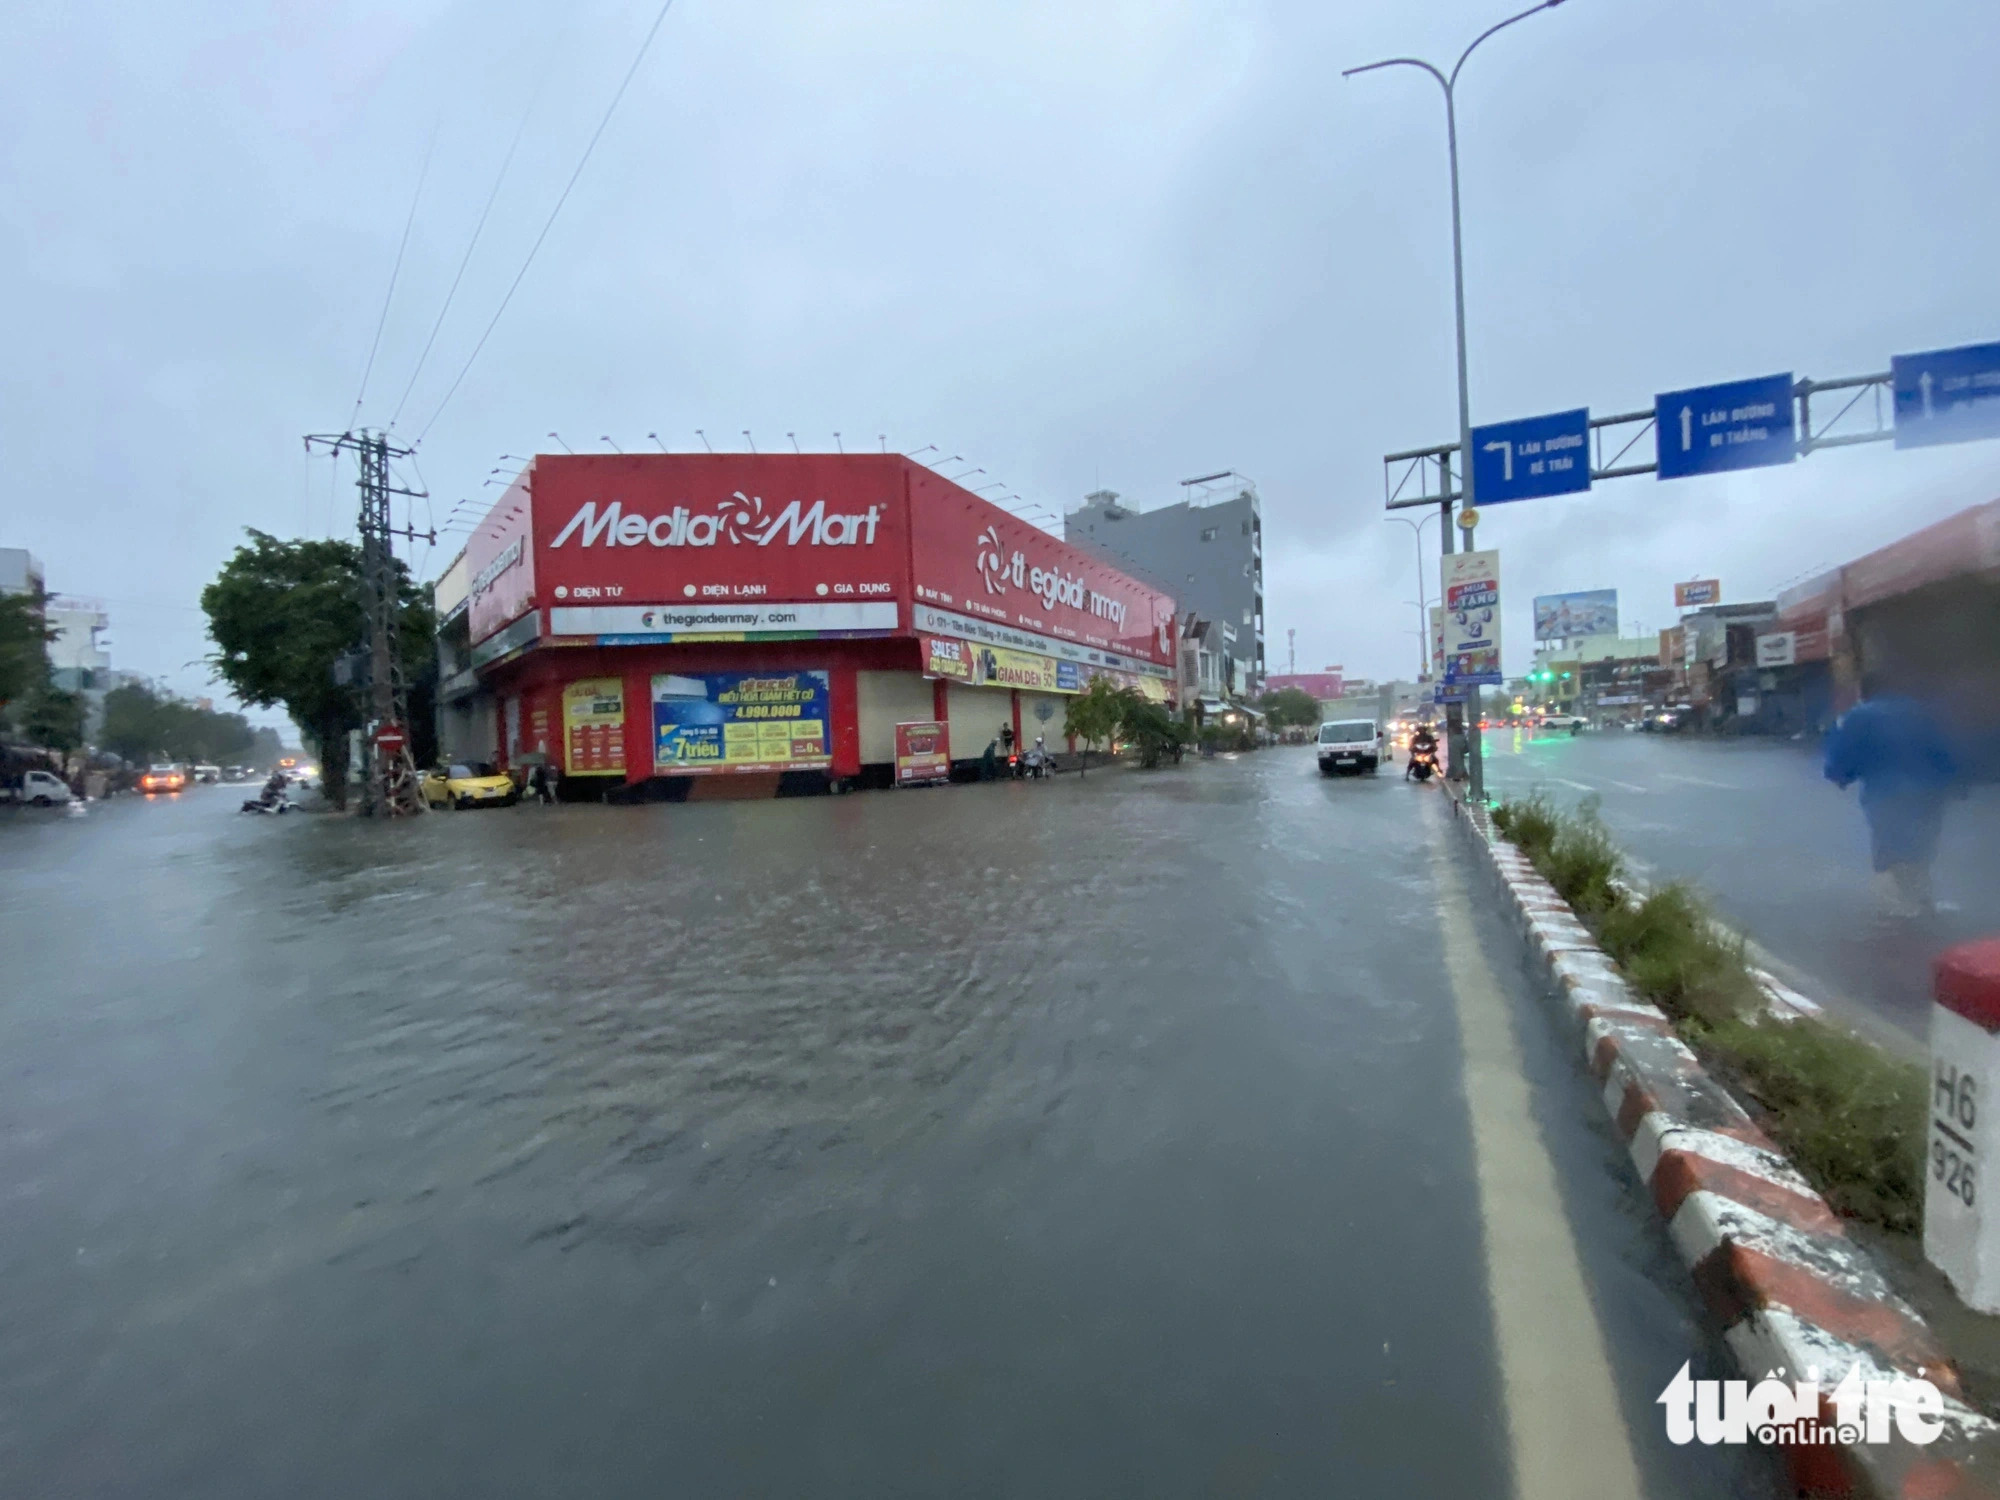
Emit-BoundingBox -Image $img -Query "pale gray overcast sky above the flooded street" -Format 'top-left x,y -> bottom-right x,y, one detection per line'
0,0 -> 2000,724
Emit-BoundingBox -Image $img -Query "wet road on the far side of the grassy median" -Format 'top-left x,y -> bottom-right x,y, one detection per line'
1486,730 -> 2000,1050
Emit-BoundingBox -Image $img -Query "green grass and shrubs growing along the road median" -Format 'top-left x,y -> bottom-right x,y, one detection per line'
1492,796 -> 1924,1232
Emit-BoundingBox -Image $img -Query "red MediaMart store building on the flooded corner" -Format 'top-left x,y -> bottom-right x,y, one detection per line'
446,454 -> 1174,798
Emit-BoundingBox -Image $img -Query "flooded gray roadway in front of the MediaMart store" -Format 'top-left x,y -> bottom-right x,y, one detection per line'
0,764 -> 1772,1500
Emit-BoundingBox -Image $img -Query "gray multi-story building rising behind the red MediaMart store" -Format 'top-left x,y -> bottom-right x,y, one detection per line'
1062,474 -> 1264,696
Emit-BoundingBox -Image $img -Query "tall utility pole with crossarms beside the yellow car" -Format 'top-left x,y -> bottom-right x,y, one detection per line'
306,428 -> 438,818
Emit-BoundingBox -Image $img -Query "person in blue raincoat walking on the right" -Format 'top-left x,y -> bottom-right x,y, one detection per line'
1826,678 -> 1958,916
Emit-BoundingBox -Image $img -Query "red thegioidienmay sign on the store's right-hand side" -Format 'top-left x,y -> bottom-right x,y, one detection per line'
910,466 -> 1174,668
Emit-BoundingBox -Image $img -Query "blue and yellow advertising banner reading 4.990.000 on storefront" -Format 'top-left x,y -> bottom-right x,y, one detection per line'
652,672 -> 832,776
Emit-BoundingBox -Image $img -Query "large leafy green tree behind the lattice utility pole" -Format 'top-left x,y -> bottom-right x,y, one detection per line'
202,530 -> 436,804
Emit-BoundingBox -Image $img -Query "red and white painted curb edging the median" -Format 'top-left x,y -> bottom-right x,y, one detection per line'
1452,798 -> 2000,1500
